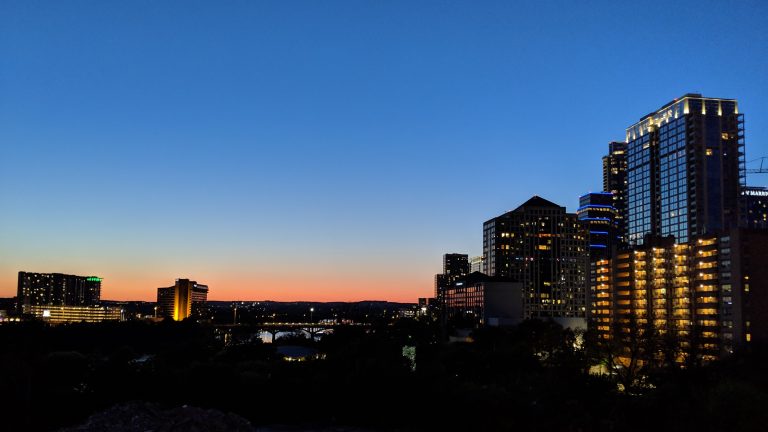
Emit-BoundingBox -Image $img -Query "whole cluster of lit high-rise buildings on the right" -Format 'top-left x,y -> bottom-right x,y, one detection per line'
435,94 -> 768,361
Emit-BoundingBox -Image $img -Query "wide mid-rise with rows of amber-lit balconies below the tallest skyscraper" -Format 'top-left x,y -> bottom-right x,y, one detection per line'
591,229 -> 768,362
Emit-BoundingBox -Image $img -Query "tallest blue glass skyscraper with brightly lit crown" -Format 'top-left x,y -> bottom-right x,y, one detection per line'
626,94 -> 746,245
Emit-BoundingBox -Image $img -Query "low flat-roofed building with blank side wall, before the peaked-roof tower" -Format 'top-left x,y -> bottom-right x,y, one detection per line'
445,272 -> 523,327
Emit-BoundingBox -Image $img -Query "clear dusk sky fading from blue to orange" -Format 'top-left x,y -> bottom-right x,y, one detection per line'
0,0 -> 768,302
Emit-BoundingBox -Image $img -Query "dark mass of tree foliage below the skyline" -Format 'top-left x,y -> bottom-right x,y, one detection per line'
0,319 -> 768,431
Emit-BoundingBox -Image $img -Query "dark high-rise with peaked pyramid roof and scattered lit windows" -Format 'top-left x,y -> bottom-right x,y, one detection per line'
483,196 -> 589,326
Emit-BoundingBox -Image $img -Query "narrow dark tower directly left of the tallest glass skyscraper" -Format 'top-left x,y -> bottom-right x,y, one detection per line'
603,141 -> 627,243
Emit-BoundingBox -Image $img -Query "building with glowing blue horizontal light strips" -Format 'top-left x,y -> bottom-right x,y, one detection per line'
576,192 -> 619,261
